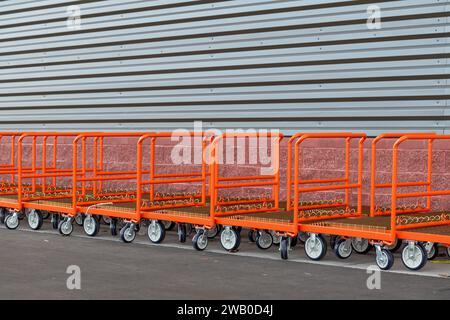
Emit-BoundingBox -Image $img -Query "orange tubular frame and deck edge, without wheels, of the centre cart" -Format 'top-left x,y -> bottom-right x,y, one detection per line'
210,133 -> 296,234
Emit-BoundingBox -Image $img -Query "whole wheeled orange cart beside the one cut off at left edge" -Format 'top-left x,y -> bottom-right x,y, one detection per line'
12,132 -> 78,230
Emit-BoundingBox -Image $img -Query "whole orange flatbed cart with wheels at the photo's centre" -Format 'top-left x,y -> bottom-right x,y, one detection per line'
210,133 -> 297,259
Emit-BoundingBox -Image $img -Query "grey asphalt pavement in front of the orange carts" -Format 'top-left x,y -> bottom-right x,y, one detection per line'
0,222 -> 450,299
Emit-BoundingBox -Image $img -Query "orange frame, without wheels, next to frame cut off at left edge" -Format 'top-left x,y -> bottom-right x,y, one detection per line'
17,132 -> 78,213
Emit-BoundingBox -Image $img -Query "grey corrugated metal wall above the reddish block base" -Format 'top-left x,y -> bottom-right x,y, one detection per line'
0,0 -> 450,134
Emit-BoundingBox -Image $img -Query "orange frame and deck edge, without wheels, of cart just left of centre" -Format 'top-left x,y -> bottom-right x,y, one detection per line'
137,132 -> 214,229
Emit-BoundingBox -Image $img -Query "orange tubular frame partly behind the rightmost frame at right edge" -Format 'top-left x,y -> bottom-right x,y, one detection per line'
370,133 -> 433,217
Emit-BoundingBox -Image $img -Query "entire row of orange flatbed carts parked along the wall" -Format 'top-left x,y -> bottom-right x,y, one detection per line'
0,131 -> 450,270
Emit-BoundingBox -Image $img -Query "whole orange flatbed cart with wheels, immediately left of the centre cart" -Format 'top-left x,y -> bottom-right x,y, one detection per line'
133,132 -> 218,251
